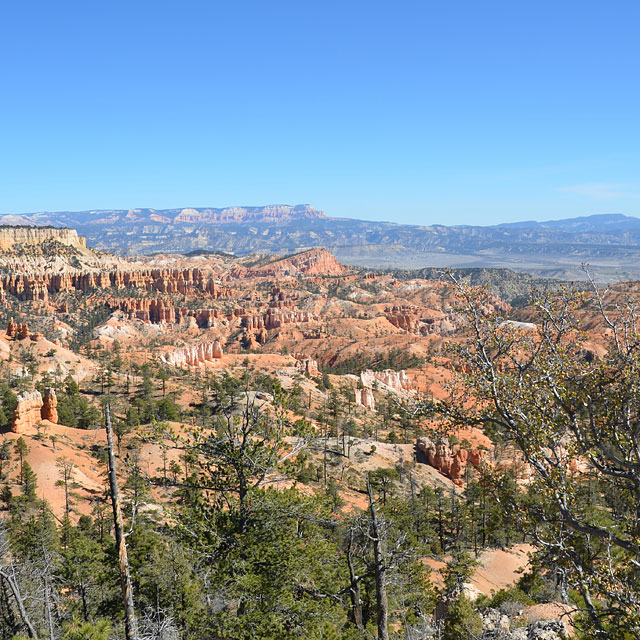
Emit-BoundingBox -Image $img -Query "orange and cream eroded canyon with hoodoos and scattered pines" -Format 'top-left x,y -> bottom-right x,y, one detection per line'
0,221 -> 629,640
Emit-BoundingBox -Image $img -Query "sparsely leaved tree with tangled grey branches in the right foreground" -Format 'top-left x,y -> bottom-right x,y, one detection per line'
417,272 -> 640,637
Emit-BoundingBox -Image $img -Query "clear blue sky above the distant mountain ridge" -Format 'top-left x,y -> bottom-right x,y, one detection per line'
0,0 -> 640,224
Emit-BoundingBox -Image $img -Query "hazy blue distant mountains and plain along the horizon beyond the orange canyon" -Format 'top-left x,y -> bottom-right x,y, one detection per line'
0,205 -> 640,280
